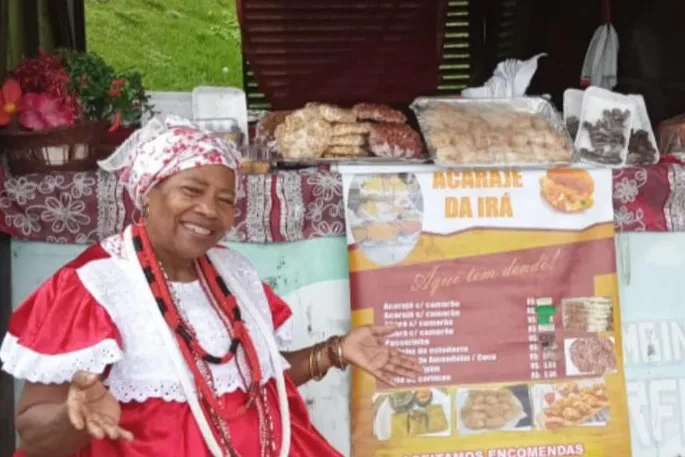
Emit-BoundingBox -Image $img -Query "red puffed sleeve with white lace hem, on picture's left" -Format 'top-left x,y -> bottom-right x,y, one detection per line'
0,267 -> 122,384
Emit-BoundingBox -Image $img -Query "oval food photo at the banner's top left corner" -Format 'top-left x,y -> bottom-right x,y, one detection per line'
347,173 -> 423,265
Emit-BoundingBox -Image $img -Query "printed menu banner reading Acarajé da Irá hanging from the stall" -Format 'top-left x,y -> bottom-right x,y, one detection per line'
342,167 -> 630,457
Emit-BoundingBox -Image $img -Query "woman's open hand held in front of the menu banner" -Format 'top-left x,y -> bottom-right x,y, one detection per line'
342,325 -> 423,386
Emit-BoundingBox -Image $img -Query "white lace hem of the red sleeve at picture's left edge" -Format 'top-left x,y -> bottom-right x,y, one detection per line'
0,333 -> 122,384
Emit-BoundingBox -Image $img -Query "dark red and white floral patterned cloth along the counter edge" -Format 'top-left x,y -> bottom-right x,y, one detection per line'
0,164 -> 685,243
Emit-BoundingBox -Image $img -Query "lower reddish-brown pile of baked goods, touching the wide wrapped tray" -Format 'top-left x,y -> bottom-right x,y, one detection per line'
369,123 -> 423,158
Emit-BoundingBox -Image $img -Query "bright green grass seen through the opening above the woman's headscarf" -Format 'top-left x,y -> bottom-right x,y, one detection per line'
85,0 -> 243,91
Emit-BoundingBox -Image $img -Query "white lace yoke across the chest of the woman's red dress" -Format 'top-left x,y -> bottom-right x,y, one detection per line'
79,236 -> 294,403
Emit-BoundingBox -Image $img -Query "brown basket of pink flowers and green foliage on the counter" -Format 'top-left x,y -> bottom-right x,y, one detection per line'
0,51 -> 152,174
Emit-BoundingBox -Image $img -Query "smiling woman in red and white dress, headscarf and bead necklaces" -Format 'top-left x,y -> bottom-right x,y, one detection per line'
0,118 -> 419,457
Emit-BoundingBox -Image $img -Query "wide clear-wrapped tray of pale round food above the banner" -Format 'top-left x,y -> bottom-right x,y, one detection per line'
411,97 -> 576,168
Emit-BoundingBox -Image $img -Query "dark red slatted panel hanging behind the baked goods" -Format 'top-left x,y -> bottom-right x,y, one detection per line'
238,0 -> 452,109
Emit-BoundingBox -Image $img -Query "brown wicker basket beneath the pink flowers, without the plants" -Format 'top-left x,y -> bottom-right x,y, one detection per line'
0,121 -> 115,175
